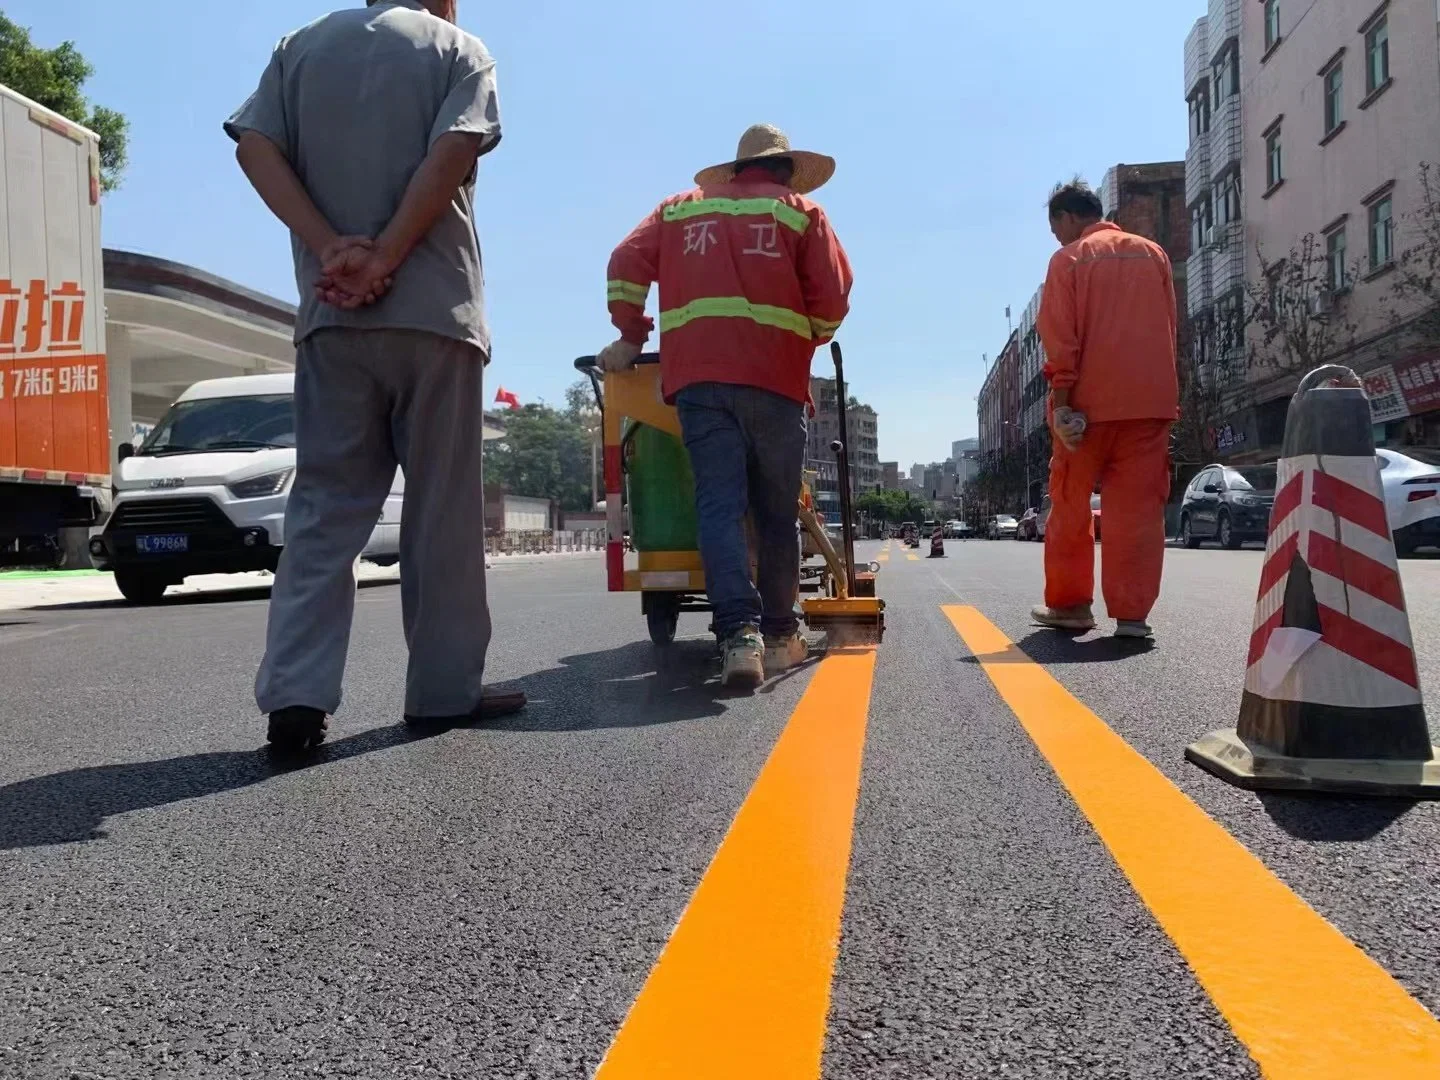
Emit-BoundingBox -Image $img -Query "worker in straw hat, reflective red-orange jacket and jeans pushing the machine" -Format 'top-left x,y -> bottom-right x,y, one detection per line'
598,124 -> 851,687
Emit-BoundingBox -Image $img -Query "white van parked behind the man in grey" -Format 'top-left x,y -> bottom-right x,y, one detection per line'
89,374 -> 405,603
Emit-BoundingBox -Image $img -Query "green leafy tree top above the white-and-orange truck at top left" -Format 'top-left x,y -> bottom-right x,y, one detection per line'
0,14 -> 130,192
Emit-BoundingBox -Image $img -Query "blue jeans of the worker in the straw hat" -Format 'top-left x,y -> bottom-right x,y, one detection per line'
675,383 -> 805,641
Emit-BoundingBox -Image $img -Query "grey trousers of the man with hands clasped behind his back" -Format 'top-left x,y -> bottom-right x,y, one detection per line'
255,328 -> 490,717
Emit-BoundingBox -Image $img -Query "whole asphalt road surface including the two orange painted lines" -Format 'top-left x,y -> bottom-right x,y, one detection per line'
0,541 -> 1440,1080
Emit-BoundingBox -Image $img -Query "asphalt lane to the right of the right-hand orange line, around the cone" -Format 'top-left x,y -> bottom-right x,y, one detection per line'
891,541 -> 1440,1014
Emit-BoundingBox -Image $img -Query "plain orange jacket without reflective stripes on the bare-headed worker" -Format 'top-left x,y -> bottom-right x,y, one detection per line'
1037,222 -> 1179,423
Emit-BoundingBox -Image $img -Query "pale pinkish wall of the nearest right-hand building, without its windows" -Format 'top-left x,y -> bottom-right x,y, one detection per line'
1241,0 -> 1440,355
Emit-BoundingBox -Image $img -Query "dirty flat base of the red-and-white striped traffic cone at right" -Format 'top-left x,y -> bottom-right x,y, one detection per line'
1185,729 -> 1440,799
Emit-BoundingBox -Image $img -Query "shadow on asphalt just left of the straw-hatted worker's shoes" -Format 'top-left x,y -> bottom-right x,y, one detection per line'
485,639 -> 733,732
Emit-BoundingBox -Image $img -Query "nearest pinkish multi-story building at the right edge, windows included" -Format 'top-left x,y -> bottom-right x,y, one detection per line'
1238,0 -> 1440,455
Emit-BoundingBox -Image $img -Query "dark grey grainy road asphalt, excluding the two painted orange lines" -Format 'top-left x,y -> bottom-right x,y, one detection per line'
0,541 -> 1440,1080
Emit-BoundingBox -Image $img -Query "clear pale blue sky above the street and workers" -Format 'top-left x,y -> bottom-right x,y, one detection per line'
11,0 -> 1205,468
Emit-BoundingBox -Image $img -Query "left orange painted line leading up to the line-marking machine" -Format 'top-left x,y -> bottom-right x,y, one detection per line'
595,649 -> 876,1080
